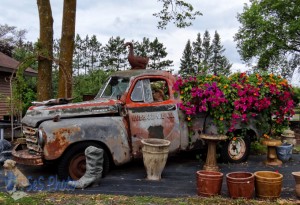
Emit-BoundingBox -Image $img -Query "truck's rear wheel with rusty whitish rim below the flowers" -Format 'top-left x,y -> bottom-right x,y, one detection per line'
220,135 -> 251,163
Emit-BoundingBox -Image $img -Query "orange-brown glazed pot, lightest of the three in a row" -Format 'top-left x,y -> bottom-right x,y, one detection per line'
254,171 -> 283,199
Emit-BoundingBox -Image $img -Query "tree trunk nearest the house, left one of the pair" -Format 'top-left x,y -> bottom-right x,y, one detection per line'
37,0 -> 53,101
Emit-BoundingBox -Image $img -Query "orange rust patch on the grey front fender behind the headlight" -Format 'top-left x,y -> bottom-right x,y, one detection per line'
44,127 -> 80,160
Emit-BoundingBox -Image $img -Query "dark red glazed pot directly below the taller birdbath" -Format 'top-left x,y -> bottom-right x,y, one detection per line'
196,170 -> 223,196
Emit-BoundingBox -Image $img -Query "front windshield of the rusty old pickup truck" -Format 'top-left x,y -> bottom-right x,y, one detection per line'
96,76 -> 129,99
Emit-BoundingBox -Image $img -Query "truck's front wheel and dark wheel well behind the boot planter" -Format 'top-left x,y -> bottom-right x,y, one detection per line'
57,142 -> 111,180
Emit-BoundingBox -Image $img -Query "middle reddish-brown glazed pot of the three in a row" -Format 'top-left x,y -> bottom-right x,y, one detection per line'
226,172 -> 254,199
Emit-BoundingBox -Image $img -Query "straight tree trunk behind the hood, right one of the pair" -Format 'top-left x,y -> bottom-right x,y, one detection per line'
58,0 -> 76,98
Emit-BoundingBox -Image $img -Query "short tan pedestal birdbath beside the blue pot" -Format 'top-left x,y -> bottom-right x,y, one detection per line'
262,139 -> 282,166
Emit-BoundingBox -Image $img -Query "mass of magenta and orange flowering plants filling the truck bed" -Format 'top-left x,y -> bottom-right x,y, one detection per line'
174,73 -> 294,139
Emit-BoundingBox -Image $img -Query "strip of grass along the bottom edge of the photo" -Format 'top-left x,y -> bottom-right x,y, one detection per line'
0,192 -> 297,205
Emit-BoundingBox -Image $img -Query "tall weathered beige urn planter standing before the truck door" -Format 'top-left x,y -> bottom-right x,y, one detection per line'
141,138 -> 170,180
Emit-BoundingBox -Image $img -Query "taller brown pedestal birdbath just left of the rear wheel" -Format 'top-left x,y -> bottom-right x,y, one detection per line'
200,134 -> 227,171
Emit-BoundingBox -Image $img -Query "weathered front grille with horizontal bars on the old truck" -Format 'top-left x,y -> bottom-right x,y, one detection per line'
23,126 -> 42,154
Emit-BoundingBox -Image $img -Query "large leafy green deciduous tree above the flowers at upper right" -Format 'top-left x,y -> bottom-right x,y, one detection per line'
235,0 -> 300,78
